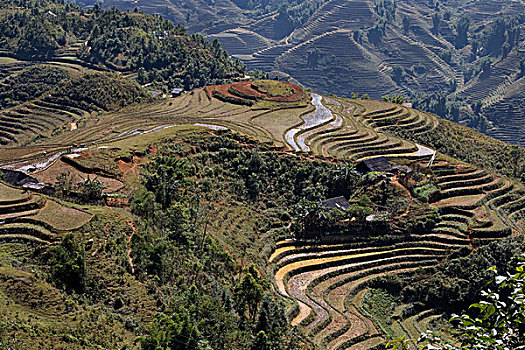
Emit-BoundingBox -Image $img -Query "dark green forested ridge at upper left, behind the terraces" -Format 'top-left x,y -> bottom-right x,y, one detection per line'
0,1 -> 244,90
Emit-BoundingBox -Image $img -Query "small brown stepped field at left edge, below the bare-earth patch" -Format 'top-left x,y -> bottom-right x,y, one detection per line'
0,182 -> 92,244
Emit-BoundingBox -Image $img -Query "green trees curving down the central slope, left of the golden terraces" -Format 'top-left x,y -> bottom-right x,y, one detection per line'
132,132 -> 360,350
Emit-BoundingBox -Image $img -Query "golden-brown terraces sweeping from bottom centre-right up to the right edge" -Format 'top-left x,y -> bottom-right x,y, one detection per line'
269,153 -> 525,349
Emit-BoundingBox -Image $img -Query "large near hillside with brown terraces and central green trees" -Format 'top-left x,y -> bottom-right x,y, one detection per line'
0,81 -> 525,350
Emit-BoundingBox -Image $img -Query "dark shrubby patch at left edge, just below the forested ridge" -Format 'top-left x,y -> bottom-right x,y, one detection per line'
0,65 -> 71,109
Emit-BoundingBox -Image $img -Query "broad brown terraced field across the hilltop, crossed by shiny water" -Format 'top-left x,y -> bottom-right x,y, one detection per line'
0,83 -> 438,167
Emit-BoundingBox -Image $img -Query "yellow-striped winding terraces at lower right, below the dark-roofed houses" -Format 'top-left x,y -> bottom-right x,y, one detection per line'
270,239 -> 457,349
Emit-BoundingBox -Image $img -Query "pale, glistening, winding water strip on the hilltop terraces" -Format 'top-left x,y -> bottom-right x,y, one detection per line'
284,93 -> 334,152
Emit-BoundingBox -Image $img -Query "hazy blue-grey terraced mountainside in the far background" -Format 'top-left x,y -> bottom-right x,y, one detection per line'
92,0 -> 525,145
